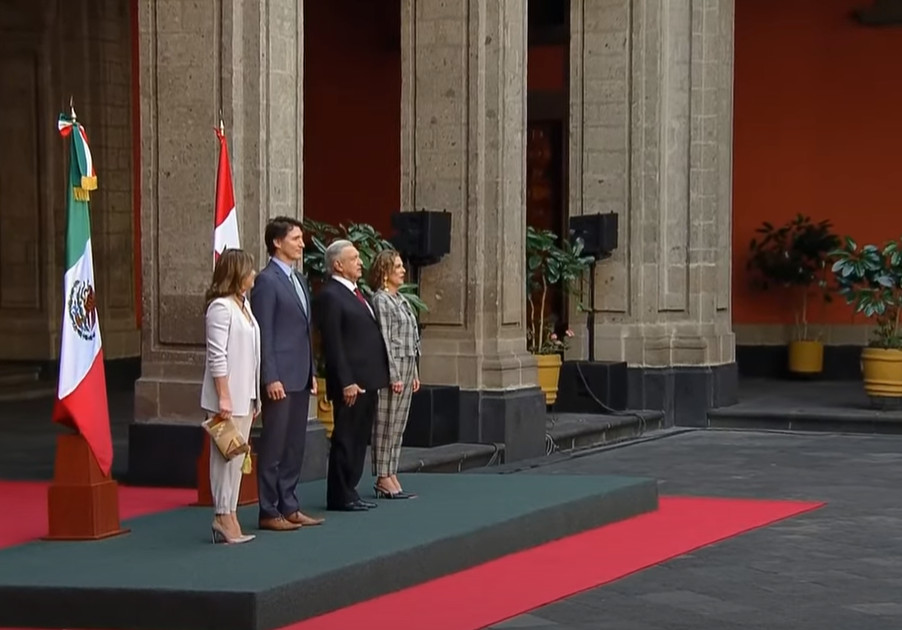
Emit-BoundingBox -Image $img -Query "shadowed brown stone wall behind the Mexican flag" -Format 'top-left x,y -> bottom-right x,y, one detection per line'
0,0 -> 140,361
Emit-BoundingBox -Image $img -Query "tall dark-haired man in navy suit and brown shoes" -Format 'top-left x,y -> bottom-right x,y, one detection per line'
251,217 -> 323,531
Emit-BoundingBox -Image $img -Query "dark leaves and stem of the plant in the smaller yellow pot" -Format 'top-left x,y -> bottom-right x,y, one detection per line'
746,214 -> 840,339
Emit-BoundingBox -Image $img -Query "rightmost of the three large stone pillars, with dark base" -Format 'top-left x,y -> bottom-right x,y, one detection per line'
570,0 -> 736,423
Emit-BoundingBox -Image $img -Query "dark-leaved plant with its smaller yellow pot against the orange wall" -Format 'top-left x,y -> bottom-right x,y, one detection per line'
747,214 -> 839,375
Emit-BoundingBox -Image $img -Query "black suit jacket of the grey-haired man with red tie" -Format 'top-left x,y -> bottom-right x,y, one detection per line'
315,280 -> 389,400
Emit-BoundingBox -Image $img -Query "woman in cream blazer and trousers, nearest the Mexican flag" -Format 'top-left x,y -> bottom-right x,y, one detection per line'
201,249 -> 260,544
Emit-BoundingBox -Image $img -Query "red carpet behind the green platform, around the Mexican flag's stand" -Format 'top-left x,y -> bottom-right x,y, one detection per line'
0,481 -> 197,549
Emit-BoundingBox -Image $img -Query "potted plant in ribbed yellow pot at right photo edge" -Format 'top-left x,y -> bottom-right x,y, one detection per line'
833,237 -> 902,406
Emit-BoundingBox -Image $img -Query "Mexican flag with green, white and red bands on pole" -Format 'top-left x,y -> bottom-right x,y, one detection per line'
53,111 -> 113,475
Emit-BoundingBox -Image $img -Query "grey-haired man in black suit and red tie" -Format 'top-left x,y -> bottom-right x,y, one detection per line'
316,241 -> 389,512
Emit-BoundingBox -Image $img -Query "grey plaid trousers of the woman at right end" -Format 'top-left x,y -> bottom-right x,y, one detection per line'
372,357 -> 417,477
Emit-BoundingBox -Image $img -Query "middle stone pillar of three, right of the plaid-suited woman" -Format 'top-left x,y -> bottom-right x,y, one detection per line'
401,0 -> 545,460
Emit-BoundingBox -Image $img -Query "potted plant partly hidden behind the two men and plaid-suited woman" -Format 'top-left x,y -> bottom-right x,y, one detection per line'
304,219 -> 428,437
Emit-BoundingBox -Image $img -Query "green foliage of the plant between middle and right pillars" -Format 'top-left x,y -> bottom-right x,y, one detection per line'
526,227 -> 594,354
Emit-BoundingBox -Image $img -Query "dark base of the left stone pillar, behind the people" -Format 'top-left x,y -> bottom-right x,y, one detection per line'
126,421 -> 329,488
